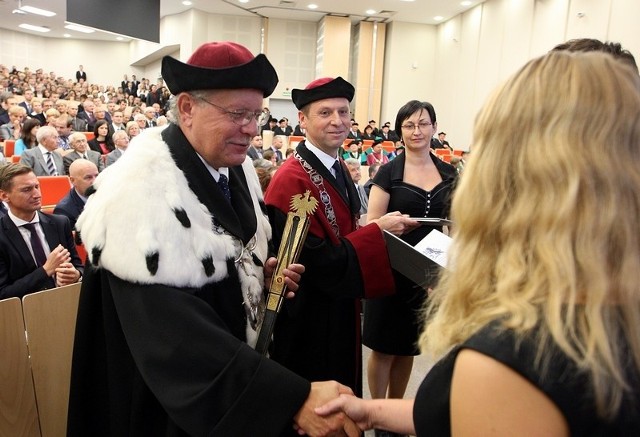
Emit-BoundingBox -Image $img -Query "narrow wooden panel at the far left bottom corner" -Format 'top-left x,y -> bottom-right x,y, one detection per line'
0,297 -> 41,437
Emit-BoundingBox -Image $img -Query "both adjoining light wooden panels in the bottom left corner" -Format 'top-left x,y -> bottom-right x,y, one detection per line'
0,283 -> 80,437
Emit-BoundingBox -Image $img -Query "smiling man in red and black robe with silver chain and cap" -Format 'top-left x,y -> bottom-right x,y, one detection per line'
265,77 -> 417,402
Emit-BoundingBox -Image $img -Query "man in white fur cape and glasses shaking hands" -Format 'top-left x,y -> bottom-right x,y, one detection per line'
68,43 -> 358,436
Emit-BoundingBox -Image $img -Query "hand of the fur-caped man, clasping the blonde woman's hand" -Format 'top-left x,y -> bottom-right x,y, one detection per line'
293,381 -> 360,437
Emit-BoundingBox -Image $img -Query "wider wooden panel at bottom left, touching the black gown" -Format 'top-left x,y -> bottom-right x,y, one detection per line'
22,283 -> 81,437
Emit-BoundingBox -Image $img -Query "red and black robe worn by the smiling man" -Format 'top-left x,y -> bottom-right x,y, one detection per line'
265,142 -> 395,395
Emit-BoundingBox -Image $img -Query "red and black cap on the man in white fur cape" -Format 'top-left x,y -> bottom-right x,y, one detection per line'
162,41 -> 278,97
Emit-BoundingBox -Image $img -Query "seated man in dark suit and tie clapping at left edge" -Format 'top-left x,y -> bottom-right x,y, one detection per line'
0,164 -> 83,299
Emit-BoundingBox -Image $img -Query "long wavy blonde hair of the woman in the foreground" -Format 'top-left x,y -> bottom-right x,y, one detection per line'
420,52 -> 640,417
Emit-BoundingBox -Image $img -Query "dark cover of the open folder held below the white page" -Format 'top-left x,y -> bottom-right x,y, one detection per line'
384,231 -> 446,288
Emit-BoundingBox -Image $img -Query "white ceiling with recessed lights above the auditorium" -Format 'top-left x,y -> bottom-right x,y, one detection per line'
0,0 -> 485,41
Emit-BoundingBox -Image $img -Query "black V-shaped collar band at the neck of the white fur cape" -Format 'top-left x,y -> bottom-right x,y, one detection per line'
162,124 -> 257,244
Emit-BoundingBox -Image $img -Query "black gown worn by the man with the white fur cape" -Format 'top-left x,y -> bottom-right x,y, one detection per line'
68,125 -> 310,436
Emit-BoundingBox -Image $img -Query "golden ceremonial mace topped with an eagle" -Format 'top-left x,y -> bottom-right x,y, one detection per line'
256,190 -> 318,355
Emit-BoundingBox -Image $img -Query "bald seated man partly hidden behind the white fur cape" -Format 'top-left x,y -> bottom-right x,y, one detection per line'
53,160 -> 98,229
